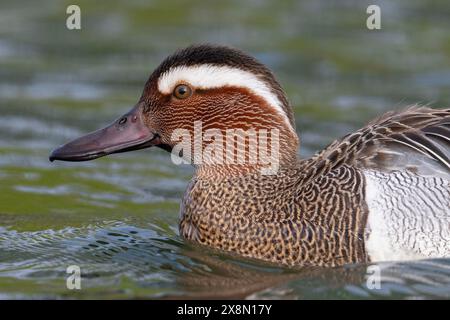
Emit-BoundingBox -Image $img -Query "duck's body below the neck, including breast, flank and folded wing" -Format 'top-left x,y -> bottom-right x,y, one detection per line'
180,107 -> 450,266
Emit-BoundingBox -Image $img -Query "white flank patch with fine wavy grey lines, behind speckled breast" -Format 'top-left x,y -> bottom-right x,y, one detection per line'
364,170 -> 450,261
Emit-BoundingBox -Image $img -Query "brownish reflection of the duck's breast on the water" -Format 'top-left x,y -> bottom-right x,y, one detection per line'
164,247 -> 365,299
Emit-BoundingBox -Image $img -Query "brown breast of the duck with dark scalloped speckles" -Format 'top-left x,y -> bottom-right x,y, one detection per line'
180,161 -> 368,266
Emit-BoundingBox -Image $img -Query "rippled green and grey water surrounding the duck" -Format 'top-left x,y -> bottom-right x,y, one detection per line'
0,0 -> 450,299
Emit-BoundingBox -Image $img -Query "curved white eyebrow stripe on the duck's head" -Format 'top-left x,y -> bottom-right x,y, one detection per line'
158,64 -> 295,133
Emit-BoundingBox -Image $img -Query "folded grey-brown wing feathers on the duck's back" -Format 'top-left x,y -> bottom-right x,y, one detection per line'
315,106 -> 450,180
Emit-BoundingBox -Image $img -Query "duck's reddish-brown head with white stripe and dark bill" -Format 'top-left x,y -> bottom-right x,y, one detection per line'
50,45 -> 298,175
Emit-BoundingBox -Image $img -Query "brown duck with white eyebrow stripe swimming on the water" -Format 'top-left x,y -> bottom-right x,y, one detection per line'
49,44 -> 450,267
